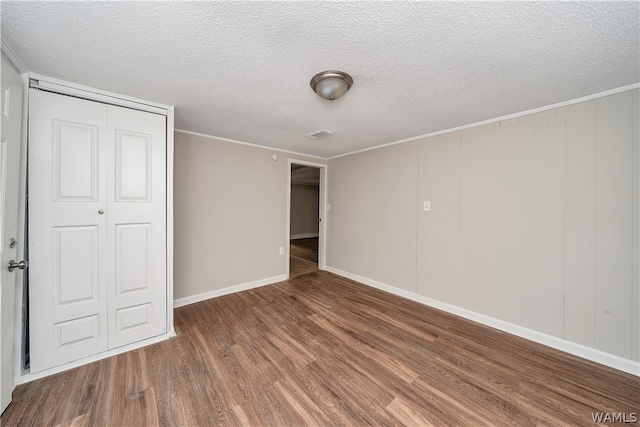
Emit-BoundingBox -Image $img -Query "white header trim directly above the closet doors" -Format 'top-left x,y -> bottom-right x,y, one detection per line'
29,73 -> 169,116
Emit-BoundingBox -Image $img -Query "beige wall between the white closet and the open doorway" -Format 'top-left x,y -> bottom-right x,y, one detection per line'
174,132 -> 324,299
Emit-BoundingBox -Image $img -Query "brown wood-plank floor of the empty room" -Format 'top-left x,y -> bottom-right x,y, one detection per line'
0,271 -> 640,426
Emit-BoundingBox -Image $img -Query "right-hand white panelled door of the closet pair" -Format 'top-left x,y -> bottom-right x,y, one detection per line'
106,106 -> 167,348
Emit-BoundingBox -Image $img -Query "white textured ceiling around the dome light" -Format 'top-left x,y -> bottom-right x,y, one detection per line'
0,1 -> 640,157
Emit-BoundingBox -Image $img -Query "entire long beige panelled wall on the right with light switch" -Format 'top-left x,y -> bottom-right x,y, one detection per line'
327,90 -> 640,361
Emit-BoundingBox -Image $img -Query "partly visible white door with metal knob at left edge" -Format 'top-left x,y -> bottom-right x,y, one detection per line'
0,55 -> 23,412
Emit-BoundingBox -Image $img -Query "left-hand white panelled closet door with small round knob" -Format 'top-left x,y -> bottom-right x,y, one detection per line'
28,89 -> 108,372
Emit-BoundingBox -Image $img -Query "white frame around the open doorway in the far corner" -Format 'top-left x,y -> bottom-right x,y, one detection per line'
285,158 -> 327,279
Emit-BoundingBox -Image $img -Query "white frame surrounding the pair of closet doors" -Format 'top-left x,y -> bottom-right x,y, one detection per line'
14,73 -> 176,385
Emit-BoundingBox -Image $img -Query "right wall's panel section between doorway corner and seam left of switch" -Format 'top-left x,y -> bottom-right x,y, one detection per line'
327,144 -> 418,292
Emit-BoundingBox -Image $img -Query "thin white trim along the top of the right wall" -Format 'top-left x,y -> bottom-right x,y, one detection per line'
327,83 -> 640,160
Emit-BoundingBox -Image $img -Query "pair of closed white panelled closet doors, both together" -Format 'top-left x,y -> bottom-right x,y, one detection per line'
29,89 -> 167,373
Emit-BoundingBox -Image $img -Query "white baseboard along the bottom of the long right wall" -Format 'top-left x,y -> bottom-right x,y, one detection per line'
327,266 -> 640,376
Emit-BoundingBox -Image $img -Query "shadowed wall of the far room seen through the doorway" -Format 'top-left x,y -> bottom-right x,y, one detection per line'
291,184 -> 319,237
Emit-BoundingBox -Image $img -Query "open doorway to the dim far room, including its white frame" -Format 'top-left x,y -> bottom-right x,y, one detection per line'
287,160 -> 326,277
